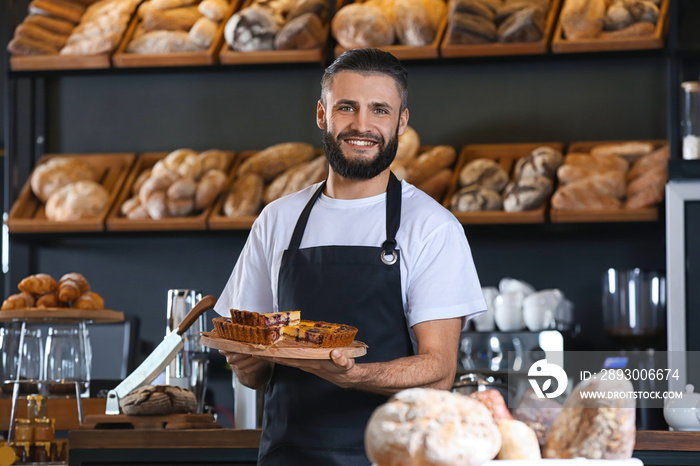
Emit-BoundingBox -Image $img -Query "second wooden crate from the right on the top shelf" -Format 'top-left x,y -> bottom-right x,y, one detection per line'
440,0 -> 562,58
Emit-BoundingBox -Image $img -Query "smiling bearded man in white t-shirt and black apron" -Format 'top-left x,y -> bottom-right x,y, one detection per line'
215,49 -> 486,466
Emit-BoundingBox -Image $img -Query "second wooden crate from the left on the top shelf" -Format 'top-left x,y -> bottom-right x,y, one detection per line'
112,0 -> 240,68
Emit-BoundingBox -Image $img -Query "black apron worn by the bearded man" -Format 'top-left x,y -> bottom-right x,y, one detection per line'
258,173 -> 413,466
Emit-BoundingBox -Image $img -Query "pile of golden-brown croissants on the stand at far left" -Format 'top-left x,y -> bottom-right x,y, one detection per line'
2,272 -> 104,311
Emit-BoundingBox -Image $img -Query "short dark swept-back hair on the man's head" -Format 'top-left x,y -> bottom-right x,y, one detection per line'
321,48 -> 408,111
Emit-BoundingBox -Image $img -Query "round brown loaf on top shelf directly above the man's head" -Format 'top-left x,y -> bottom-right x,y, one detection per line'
331,3 -> 396,49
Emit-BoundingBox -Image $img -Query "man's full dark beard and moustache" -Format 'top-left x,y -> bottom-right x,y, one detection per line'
323,126 -> 399,181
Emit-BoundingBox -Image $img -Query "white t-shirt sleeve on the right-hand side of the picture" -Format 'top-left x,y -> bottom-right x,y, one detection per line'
407,222 -> 486,328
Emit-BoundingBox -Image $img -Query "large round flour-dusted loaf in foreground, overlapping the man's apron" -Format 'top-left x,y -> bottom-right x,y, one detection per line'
365,388 -> 501,466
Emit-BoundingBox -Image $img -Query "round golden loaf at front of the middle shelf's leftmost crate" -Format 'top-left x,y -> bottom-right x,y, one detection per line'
46,181 -> 109,221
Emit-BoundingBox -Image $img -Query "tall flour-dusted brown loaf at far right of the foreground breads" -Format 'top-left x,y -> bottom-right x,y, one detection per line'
542,377 -> 636,459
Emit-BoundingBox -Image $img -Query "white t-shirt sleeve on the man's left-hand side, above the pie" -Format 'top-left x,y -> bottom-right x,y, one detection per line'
214,217 -> 274,317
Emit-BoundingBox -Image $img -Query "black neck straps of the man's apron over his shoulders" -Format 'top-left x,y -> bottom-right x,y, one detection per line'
289,172 -> 401,251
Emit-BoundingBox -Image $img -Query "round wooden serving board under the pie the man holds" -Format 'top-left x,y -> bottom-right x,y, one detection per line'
200,332 -> 367,359
